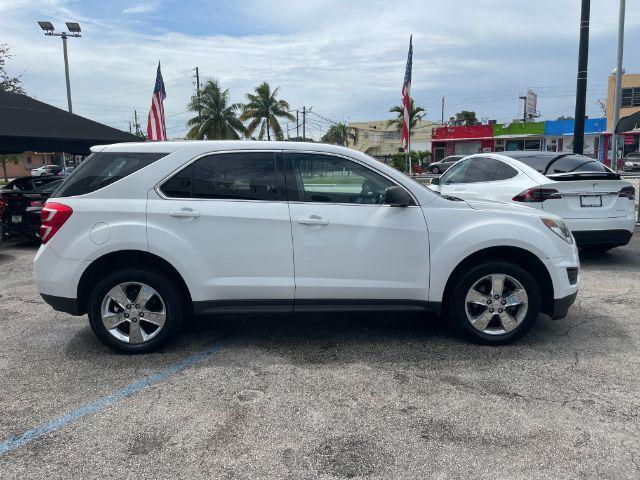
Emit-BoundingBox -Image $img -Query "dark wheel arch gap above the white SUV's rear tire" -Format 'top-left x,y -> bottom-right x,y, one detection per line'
77,250 -> 192,315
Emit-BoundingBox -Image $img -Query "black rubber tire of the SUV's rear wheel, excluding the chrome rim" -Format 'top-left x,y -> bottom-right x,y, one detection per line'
88,268 -> 186,353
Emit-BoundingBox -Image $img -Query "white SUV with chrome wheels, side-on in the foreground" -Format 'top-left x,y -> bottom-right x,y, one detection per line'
34,141 -> 579,352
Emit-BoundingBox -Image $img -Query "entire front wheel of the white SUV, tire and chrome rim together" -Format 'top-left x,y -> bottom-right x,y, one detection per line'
448,261 -> 540,345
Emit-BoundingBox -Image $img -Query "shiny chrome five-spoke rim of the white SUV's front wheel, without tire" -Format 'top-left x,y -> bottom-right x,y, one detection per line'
465,273 -> 529,335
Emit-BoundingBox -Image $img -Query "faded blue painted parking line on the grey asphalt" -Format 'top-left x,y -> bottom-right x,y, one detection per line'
0,343 -> 222,456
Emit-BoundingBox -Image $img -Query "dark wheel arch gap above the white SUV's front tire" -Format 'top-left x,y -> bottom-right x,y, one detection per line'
442,246 -> 554,315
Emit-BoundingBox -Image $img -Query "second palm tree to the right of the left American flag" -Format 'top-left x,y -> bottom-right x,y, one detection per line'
240,82 -> 296,140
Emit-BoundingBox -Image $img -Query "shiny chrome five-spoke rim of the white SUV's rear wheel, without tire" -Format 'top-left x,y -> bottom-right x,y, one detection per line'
100,282 -> 167,344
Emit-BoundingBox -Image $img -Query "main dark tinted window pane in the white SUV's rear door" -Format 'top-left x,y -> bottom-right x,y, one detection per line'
192,152 -> 286,200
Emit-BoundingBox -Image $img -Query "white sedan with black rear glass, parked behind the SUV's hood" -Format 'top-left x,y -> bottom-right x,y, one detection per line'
430,151 -> 635,251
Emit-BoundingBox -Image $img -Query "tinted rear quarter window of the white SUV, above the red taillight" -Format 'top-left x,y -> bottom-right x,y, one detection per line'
55,152 -> 167,197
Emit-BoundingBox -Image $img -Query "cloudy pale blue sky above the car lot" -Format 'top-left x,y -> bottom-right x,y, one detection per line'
0,0 -> 640,137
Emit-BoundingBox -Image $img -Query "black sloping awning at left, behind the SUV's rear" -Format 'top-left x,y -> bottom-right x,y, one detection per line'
0,92 -> 141,155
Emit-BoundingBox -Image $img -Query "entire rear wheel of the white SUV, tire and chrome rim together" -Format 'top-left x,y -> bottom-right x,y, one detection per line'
88,268 -> 185,353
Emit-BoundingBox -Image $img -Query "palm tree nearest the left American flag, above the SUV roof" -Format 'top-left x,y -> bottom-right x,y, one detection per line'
187,79 -> 245,140
